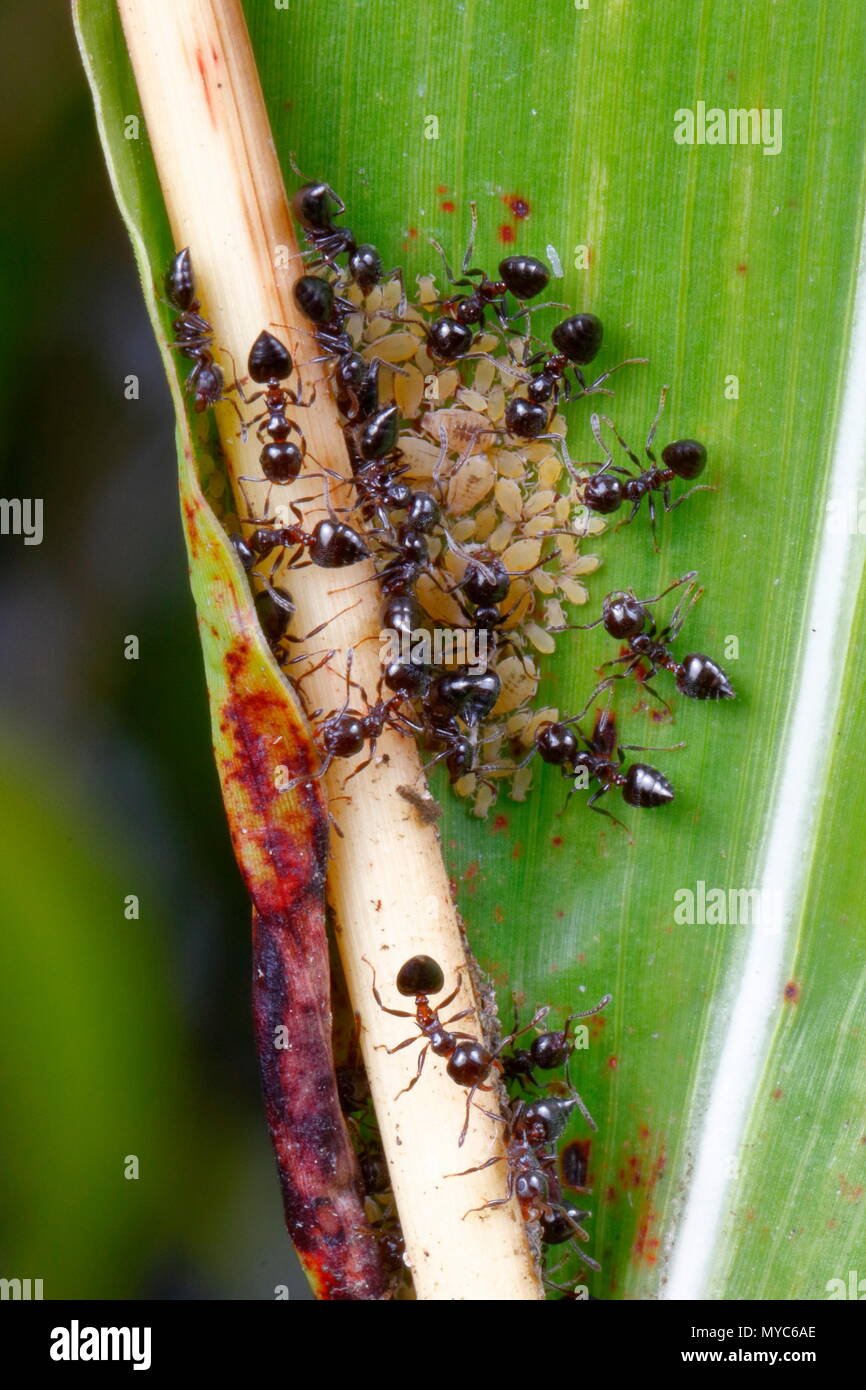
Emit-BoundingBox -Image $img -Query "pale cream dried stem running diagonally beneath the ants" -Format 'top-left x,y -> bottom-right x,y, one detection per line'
118,0 -> 542,1300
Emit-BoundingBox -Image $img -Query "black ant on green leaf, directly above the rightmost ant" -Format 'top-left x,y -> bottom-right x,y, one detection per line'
571,386 -> 716,550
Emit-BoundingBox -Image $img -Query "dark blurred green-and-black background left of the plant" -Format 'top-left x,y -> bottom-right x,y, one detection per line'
0,0 -> 307,1298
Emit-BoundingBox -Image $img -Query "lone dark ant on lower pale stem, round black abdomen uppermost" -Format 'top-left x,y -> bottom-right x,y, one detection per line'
364,955 -> 545,1145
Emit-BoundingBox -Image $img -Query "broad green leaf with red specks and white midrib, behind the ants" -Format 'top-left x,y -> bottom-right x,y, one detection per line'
83,0 -> 866,1298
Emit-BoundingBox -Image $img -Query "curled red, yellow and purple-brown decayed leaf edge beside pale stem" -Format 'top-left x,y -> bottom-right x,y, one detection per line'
181,450 -> 386,1300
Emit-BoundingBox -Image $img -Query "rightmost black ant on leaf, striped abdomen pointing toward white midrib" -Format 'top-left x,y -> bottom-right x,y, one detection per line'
575,570 -> 735,712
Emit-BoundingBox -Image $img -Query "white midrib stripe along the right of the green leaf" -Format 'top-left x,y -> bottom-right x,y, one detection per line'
660,229 -> 866,1300
